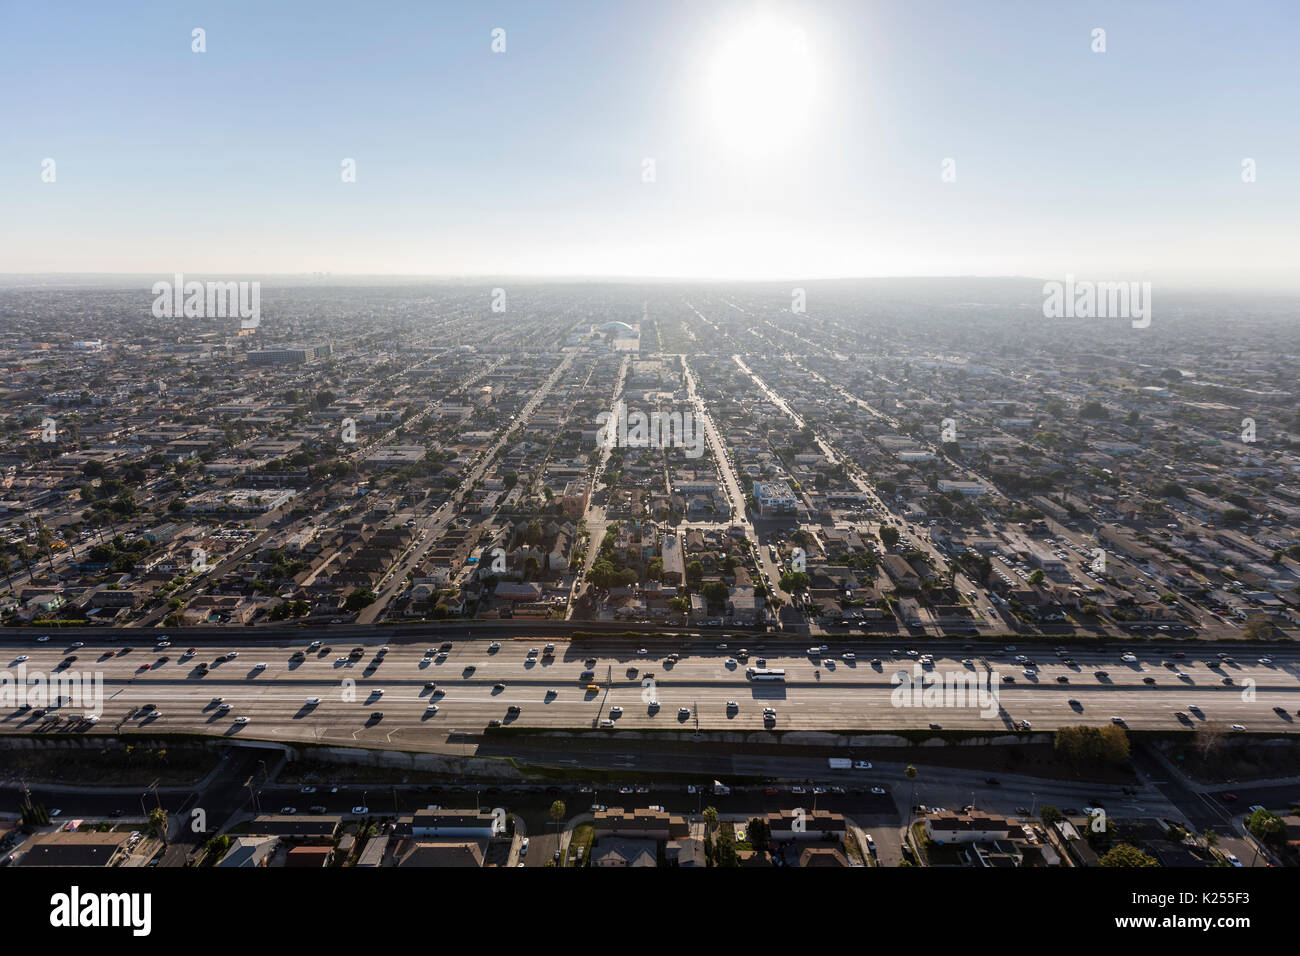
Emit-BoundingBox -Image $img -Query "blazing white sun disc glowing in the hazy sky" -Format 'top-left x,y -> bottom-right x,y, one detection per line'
705,16 -> 816,152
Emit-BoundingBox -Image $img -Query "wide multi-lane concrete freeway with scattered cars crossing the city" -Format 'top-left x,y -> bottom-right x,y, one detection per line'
0,632 -> 1300,753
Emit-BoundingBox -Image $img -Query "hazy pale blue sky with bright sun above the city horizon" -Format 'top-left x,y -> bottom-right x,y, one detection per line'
0,0 -> 1300,291
